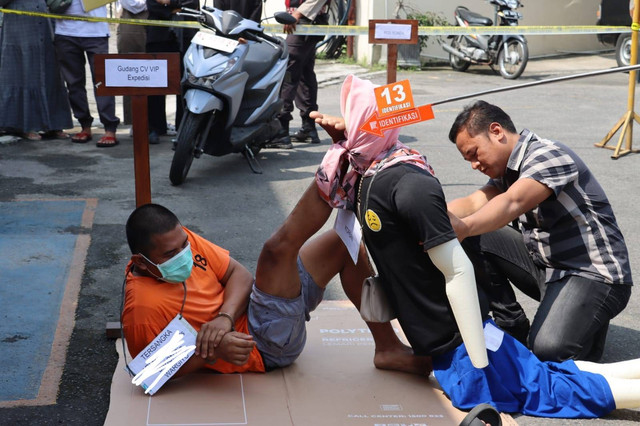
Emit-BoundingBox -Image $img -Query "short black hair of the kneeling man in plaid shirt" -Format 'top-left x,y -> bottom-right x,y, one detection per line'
449,101 -> 517,143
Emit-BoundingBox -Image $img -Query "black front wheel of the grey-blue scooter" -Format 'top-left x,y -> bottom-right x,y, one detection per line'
169,111 -> 205,185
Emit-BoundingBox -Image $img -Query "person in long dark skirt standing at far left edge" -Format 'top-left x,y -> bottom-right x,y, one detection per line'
0,0 -> 73,140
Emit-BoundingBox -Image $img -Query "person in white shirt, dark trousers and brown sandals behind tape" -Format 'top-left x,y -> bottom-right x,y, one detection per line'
55,0 -> 120,147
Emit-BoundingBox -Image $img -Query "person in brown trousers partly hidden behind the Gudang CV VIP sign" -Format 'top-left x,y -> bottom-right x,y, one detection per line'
116,0 -> 149,124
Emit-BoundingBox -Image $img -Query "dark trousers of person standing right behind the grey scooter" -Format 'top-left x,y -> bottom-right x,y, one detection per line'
280,35 -> 322,121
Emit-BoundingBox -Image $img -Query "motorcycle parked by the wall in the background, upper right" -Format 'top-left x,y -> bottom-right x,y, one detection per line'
442,0 -> 529,80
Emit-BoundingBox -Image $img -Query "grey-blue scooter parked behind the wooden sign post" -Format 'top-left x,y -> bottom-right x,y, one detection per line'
169,6 -> 295,185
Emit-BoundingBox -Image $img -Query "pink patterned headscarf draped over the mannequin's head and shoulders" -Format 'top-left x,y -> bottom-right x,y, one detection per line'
316,75 -> 433,209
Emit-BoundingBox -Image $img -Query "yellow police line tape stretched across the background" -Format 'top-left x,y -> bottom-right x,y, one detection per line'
0,8 -> 638,36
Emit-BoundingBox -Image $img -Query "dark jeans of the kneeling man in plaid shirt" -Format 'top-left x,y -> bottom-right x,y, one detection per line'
462,227 -> 631,361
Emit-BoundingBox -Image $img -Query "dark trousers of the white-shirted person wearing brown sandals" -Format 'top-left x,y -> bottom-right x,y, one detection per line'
54,35 -> 120,132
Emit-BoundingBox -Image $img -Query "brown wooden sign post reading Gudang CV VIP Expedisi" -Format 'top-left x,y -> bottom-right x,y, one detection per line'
94,53 -> 180,207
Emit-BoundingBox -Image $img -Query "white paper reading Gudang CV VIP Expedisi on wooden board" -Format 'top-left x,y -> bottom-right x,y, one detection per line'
104,59 -> 168,87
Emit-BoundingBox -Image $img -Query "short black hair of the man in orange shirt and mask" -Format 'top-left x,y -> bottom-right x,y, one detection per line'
126,204 -> 180,254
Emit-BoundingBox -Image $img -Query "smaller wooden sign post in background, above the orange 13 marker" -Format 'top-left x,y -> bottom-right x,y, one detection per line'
369,19 -> 418,84
